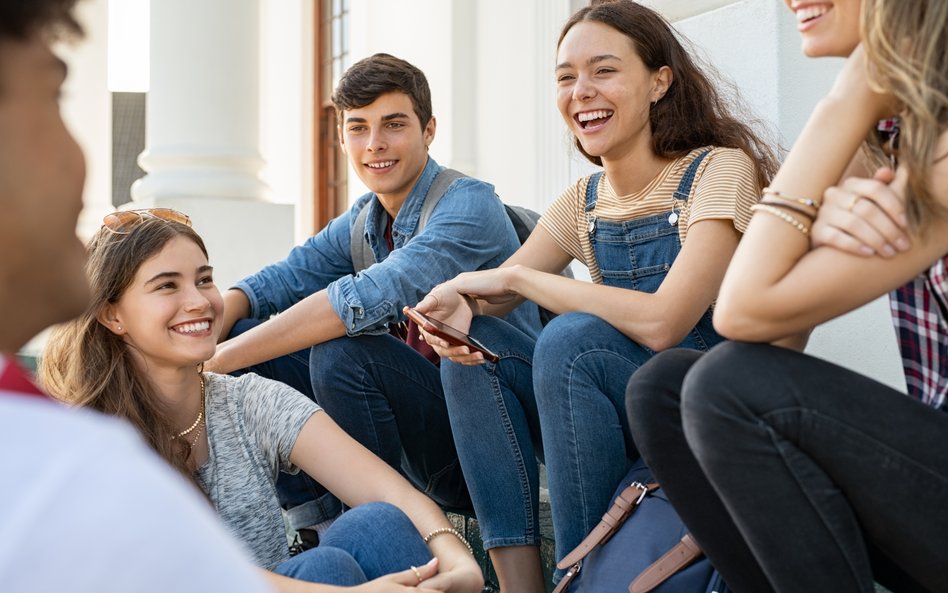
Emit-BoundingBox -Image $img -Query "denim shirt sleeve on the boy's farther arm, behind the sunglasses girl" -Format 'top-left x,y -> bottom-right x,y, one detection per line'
234,207 -> 363,319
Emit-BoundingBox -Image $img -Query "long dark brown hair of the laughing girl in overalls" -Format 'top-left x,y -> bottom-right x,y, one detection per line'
556,0 -> 778,187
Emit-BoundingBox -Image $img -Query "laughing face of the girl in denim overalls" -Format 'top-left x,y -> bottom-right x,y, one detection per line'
556,21 -> 671,162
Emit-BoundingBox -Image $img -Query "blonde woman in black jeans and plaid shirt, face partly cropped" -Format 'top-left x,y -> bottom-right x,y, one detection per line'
627,0 -> 948,593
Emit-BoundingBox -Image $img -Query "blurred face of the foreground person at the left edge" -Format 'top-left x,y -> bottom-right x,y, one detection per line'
0,38 -> 89,351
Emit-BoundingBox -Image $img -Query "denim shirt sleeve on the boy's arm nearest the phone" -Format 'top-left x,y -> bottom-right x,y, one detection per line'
328,178 -> 518,336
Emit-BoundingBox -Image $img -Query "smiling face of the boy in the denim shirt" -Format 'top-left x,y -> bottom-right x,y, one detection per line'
339,92 -> 435,212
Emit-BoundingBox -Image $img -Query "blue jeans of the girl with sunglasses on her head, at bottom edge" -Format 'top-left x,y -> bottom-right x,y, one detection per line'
274,502 -> 431,587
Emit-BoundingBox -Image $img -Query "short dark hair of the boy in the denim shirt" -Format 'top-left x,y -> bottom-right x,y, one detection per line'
332,53 -> 431,128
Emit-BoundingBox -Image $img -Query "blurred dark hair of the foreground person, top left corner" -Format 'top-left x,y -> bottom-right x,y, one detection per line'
0,0 -> 82,41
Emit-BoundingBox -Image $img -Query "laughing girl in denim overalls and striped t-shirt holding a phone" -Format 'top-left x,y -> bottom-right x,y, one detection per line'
418,0 -> 775,593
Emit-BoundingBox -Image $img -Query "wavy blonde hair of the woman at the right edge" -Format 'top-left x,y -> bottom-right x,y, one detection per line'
860,0 -> 948,232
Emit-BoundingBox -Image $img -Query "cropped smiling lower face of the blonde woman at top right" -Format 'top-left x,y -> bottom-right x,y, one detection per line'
784,0 -> 861,58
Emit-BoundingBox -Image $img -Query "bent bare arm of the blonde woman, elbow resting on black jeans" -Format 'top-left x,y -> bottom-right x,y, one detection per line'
715,50 -> 948,341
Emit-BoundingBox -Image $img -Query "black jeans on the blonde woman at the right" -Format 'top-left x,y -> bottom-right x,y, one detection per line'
626,342 -> 948,593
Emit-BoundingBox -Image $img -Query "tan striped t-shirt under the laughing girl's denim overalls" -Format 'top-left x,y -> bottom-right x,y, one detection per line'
538,148 -> 760,284
